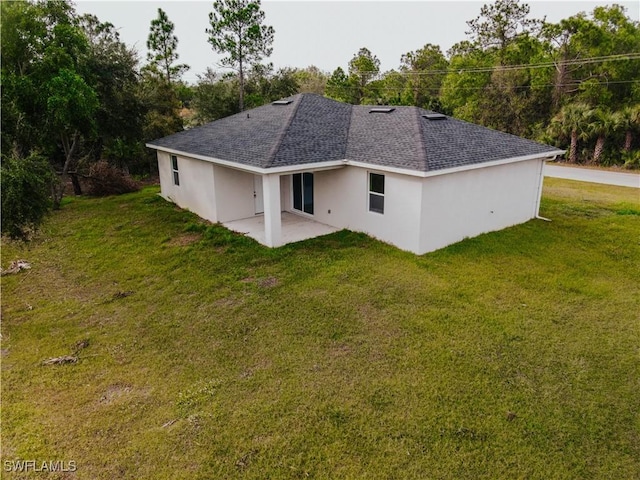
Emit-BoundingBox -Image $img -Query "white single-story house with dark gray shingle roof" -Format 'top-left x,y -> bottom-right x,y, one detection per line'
147,94 -> 563,254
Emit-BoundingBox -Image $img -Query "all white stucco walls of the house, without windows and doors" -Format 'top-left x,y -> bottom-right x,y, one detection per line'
158,152 -> 543,254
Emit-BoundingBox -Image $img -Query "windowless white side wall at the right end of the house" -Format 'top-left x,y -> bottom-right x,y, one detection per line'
417,159 -> 543,254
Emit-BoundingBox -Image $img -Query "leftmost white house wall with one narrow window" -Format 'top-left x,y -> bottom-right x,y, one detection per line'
158,152 -> 218,222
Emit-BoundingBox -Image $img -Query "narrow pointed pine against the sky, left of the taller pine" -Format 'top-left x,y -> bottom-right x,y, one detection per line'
147,8 -> 189,83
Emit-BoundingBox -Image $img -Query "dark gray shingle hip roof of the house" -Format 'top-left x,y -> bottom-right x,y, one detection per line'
149,94 -> 560,172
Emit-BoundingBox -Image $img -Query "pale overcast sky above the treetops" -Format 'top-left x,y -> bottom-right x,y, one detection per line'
76,0 -> 640,83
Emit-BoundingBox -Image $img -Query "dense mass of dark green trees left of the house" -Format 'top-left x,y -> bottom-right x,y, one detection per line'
0,0 -> 154,221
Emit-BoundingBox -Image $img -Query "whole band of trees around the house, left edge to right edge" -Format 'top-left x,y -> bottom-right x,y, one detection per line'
0,0 -> 640,238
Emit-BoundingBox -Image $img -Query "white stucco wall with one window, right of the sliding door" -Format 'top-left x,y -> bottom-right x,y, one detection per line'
306,167 -> 422,252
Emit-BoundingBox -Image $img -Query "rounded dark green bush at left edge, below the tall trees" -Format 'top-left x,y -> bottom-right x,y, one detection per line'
0,151 -> 53,240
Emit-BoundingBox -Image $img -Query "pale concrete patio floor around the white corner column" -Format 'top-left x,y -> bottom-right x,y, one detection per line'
222,212 -> 338,246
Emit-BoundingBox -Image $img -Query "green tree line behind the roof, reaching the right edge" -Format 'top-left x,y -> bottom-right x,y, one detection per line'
189,0 -> 640,168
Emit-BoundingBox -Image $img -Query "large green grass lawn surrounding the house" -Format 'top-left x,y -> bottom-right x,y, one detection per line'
2,179 -> 640,479
